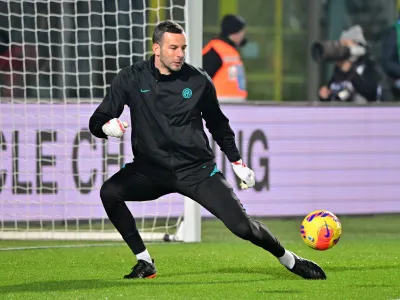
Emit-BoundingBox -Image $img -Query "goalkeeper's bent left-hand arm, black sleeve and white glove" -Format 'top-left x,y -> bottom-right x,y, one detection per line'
89,69 -> 128,138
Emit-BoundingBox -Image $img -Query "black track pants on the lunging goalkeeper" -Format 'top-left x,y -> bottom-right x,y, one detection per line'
100,162 -> 285,257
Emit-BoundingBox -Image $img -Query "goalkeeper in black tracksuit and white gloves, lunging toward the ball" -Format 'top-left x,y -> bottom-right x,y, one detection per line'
89,21 -> 326,279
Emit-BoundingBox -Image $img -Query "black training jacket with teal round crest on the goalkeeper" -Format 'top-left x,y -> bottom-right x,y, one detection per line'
89,56 -> 240,174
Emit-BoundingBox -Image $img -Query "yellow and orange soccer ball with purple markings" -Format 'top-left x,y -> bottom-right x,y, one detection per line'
300,210 -> 342,251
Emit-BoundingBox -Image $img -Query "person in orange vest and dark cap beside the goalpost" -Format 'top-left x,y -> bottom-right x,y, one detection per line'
202,15 -> 247,102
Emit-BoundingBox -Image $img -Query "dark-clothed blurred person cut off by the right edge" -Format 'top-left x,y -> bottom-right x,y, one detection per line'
381,16 -> 400,100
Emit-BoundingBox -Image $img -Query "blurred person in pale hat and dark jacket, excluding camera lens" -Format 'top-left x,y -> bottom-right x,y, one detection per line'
319,26 -> 383,103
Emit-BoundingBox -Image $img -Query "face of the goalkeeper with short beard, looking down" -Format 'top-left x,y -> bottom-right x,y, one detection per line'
154,32 -> 187,72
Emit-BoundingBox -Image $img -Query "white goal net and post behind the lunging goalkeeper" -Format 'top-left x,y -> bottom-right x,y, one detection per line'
0,0 -> 202,241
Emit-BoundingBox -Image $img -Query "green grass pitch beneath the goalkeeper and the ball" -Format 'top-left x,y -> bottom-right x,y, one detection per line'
0,215 -> 400,300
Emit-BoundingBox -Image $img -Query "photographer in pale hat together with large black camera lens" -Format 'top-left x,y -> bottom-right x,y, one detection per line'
312,25 -> 382,103
